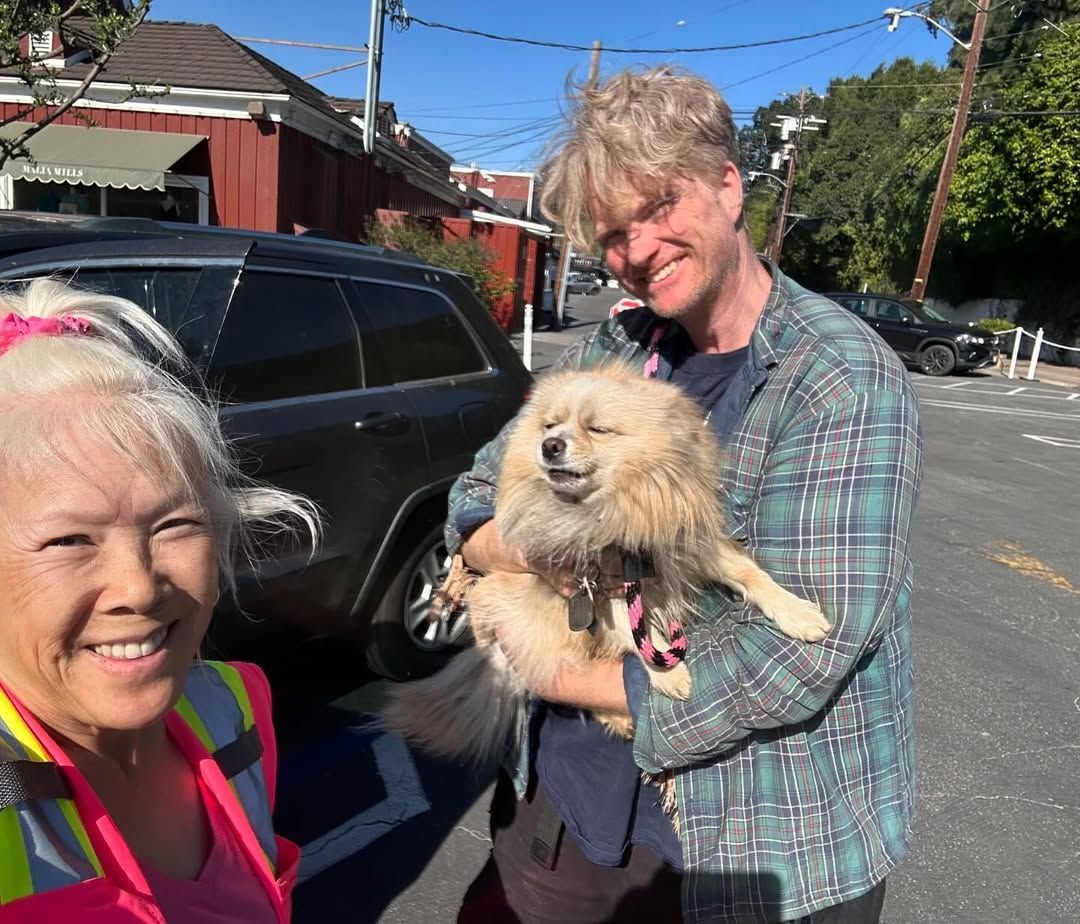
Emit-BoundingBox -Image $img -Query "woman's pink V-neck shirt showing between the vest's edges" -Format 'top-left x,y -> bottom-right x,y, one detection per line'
141,783 -> 278,924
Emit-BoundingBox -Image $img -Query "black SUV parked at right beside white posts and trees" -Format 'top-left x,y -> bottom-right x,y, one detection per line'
825,291 -> 1000,376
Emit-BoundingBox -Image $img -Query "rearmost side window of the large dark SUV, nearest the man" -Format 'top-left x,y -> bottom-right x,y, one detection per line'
353,280 -> 487,388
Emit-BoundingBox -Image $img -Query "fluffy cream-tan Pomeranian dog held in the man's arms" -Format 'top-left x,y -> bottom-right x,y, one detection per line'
382,365 -> 829,763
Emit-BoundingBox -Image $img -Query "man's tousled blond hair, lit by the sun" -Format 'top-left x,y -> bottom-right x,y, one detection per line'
540,66 -> 739,249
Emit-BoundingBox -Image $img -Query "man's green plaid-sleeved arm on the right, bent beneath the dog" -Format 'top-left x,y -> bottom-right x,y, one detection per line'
633,390 -> 921,772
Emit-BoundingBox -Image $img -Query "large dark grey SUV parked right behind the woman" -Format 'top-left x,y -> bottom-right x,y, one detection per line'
0,212 -> 530,678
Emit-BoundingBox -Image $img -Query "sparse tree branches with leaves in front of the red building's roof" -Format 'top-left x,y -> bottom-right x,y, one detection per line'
0,0 -> 151,166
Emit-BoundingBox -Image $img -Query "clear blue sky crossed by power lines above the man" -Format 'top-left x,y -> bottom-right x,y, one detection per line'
151,0 -> 950,169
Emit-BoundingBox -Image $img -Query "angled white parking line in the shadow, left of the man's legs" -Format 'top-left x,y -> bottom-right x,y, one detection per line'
297,734 -> 431,883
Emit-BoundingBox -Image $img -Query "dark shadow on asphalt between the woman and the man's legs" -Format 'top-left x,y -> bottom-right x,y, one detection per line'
264,642 -> 495,924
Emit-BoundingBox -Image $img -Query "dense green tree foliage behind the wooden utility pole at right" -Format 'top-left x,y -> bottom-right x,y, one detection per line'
747,0 -> 1080,339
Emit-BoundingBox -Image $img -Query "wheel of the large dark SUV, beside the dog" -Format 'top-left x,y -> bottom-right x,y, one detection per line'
367,526 -> 469,680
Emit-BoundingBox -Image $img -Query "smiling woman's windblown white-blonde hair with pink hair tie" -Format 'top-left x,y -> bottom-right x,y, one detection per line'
0,274 -> 321,593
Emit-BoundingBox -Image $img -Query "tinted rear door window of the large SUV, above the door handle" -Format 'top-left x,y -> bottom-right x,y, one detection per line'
211,272 -> 361,403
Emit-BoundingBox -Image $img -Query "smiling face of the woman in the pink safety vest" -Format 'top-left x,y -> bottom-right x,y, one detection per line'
0,422 -> 218,740
